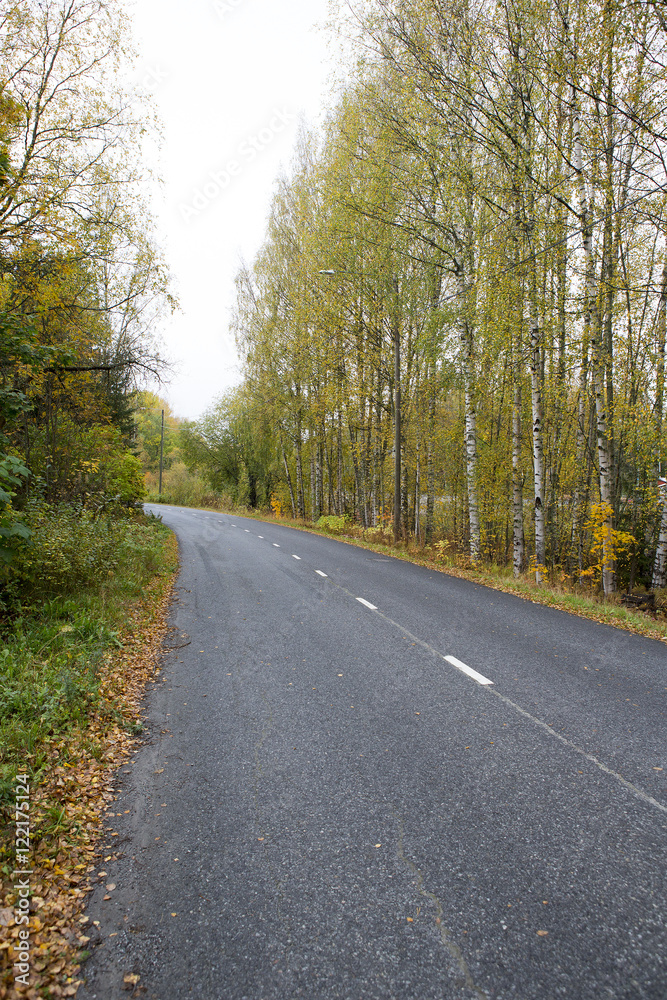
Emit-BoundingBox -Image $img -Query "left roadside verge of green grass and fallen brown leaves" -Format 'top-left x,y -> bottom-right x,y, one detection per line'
0,517 -> 178,1000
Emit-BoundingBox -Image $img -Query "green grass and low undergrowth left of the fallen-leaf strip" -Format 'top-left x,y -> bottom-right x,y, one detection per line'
0,509 -> 173,800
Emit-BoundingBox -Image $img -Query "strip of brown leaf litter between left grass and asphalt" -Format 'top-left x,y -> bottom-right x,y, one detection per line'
0,536 -> 177,1000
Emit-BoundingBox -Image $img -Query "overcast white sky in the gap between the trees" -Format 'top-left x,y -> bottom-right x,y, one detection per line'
129,0 -> 340,419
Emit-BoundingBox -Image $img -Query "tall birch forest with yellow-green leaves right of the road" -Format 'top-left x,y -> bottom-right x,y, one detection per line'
194,0 -> 667,595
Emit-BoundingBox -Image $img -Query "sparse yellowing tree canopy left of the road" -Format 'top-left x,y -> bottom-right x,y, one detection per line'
0,0 -> 174,564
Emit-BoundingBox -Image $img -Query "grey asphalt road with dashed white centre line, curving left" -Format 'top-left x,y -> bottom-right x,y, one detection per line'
78,507 -> 667,1000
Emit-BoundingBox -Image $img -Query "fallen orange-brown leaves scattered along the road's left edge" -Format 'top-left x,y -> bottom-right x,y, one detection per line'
0,540 -> 177,1000
